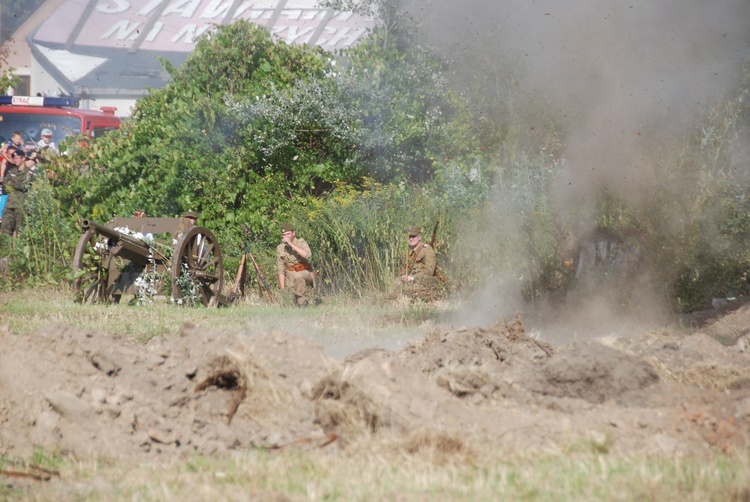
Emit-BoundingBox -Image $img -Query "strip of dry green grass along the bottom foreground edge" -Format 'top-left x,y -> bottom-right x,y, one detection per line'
4,446 -> 750,501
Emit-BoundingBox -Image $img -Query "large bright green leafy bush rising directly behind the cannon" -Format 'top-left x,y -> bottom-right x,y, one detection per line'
52,21 -> 344,246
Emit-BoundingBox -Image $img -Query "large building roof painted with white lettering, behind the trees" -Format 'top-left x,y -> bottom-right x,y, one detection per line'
22,0 -> 374,97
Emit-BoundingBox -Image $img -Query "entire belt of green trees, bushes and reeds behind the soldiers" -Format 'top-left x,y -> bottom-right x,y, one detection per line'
0,1 -> 750,311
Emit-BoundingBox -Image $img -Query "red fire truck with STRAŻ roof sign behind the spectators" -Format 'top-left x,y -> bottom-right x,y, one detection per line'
0,96 -> 121,145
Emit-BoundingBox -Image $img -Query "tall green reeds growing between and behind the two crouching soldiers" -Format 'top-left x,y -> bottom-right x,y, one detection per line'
294,181 -> 470,298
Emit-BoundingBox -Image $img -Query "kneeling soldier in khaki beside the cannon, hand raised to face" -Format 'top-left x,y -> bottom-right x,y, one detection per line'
276,224 -> 314,307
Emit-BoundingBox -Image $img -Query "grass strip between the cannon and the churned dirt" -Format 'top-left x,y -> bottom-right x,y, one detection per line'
0,289 -> 451,357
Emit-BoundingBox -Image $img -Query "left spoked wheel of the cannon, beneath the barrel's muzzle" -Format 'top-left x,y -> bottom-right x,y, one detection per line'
73,230 -> 109,303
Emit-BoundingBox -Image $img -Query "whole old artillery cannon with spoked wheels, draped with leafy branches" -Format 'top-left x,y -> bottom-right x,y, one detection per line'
73,218 -> 227,306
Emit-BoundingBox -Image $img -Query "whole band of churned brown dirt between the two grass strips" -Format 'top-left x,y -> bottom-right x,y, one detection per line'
0,298 -> 750,478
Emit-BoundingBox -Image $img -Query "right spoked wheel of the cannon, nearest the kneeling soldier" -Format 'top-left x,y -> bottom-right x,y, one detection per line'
172,227 -> 224,307
